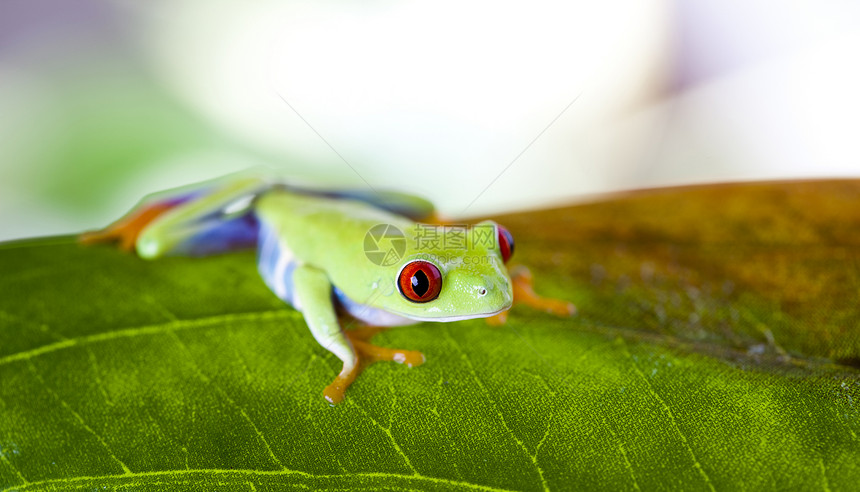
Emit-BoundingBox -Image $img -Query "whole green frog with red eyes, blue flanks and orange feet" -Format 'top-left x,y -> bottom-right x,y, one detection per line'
80,176 -> 574,404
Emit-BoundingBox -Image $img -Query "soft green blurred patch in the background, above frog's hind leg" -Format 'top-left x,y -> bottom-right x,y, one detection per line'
10,60 -> 259,213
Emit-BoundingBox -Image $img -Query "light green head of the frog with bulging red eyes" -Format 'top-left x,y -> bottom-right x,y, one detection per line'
379,221 -> 514,321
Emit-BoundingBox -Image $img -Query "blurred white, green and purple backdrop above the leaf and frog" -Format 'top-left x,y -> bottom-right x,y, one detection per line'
0,0 -> 860,240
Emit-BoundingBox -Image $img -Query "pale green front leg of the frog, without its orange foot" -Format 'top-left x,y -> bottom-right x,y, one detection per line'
292,265 -> 358,374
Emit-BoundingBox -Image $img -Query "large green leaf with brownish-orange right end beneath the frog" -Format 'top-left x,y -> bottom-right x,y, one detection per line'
0,181 -> 860,491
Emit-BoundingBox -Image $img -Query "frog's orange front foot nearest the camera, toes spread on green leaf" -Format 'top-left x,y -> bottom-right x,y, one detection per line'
323,326 -> 425,405
